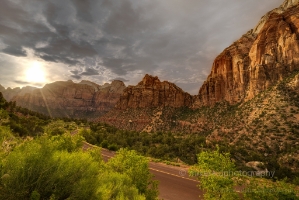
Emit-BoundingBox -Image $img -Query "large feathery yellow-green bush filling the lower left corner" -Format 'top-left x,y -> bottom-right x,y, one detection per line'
0,137 -> 101,199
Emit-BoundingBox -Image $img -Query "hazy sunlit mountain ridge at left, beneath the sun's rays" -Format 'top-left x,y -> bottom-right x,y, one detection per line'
11,81 -> 126,118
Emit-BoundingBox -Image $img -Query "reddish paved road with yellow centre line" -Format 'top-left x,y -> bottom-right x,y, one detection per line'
98,149 -> 202,200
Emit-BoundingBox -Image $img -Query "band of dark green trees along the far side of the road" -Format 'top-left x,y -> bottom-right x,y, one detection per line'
82,124 -> 205,164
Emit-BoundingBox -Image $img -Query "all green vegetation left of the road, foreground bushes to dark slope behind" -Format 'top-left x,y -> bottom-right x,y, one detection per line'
0,93 -> 158,200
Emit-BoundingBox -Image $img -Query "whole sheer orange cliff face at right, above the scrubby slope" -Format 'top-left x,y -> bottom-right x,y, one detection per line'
194,0 -> 299,107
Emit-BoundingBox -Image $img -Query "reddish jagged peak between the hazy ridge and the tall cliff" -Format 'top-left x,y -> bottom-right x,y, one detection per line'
116,74 -> 192,110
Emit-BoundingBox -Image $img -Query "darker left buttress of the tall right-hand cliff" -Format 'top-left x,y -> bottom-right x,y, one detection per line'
197,31 -> 256,105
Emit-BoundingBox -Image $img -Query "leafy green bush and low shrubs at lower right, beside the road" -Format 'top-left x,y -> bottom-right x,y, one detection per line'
189,149 -> 299,200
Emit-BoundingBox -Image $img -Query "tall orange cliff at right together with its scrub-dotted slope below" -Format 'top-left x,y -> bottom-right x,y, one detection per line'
98,1 -> 299,177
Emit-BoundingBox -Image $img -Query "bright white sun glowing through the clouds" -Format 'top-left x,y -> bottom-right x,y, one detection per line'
26,62 -> 45,83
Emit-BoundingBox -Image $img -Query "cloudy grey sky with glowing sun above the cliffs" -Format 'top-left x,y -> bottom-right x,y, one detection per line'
0,0 -> 283,94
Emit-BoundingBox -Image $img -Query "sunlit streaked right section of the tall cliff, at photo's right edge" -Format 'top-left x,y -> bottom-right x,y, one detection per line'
246,5 -> 299,99
